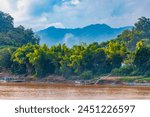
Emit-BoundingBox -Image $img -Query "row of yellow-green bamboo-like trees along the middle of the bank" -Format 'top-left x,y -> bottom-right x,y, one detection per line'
9,42 -> 126,79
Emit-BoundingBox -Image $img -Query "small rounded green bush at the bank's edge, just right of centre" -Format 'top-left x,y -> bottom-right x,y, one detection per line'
80,71 -> 93,80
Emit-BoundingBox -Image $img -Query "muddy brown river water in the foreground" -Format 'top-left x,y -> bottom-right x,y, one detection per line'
0,83 -> 150,100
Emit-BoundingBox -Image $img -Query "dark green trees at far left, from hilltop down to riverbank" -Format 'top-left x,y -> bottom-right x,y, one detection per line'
0,11 -> 39,73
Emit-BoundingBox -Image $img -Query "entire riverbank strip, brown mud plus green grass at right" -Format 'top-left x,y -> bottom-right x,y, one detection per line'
0,73 -> 150,86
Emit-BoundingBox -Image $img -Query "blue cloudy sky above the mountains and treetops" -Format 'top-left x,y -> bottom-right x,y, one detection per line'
0,0 -> 150,31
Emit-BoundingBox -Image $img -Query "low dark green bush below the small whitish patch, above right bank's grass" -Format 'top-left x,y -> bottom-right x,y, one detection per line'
112,65 -> 135,76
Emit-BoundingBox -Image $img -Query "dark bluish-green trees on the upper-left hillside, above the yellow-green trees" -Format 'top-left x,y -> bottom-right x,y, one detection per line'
0,11 -> 39,47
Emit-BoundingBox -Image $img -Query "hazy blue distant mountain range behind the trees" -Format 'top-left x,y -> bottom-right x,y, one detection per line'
37,24 -> 132,46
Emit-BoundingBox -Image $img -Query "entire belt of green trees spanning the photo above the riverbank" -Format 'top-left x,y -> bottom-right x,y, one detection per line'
0,12 -> 150,80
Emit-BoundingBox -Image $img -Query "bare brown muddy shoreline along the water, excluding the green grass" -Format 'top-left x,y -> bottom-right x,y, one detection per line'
0,73 -> 150,86
